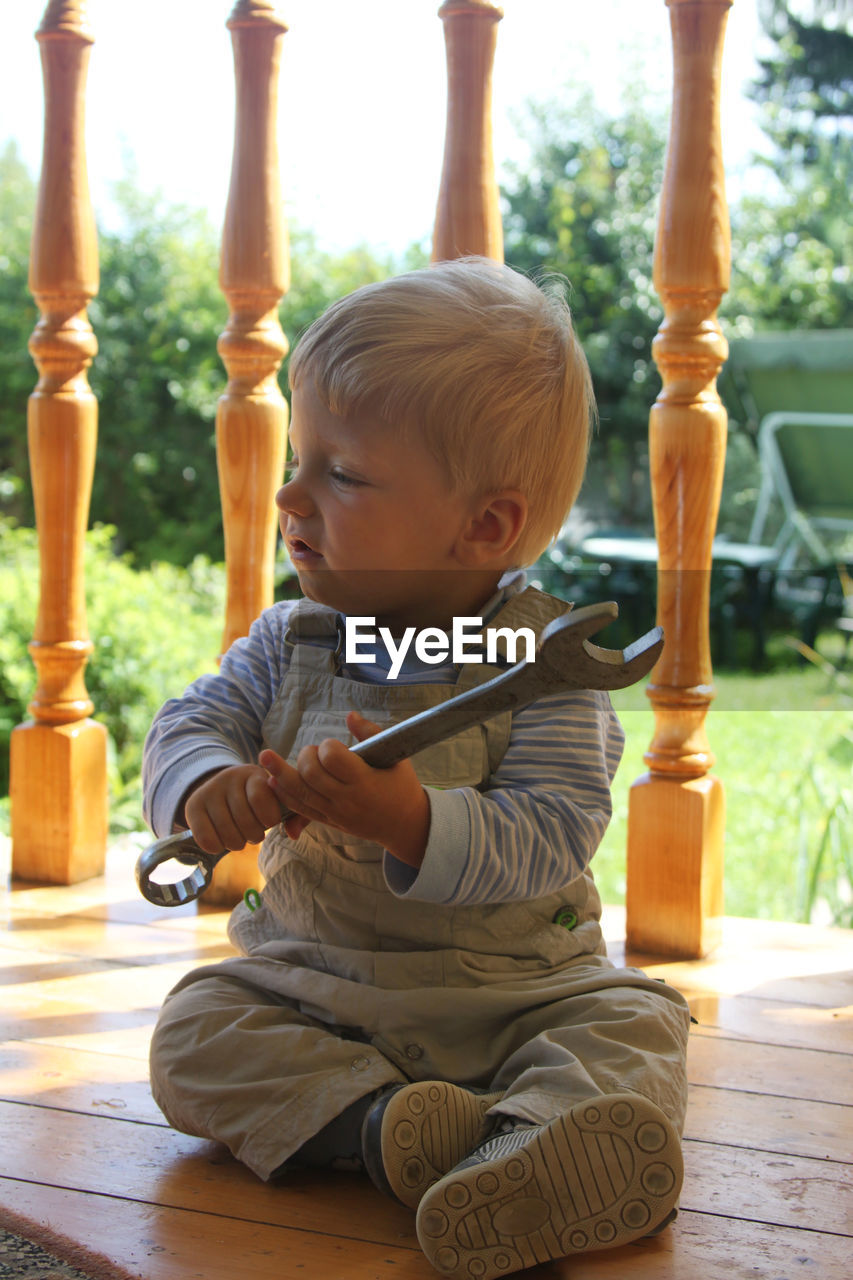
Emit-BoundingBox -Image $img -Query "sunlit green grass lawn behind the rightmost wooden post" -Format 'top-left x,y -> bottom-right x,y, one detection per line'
593,644 -> 853,924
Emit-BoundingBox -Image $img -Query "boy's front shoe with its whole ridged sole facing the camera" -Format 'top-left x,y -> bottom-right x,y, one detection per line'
418,1093 -> 683,1280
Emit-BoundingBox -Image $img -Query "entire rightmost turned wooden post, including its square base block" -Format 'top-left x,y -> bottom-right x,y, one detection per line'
628,0 -> 731,956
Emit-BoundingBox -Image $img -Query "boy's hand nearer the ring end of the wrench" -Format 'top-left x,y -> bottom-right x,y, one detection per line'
183,764 -> 282,854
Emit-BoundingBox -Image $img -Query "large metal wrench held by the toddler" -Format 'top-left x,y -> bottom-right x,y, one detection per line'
136,600 -> 663,906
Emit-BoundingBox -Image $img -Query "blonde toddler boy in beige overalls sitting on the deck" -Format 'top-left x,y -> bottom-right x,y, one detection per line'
145,259 -> 689,1280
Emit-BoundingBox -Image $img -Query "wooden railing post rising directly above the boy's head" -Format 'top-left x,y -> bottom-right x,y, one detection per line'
432,0 -> 503,262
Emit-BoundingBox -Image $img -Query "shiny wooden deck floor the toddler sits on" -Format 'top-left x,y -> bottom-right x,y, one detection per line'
0,851 -> 853,1280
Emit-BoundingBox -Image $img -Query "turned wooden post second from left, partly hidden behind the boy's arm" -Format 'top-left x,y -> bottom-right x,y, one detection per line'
205,0 -> 289,902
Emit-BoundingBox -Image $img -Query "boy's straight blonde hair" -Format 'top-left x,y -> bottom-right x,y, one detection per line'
289,257 -> 596,564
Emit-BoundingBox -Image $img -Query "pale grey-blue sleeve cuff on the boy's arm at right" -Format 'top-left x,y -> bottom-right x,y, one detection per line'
384,787 -> 471,902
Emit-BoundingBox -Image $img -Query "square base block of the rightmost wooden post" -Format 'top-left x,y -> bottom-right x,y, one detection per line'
625,773 -> 725,960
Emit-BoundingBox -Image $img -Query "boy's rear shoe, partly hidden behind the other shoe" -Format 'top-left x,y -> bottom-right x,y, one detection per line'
361,1080 -> 502,1208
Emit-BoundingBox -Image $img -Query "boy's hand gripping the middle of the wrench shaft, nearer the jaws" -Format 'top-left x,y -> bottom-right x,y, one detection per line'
257,712 -> 430,867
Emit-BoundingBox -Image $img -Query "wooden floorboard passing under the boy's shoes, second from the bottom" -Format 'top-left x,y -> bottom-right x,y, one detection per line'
0,1103 -> 853,1247
